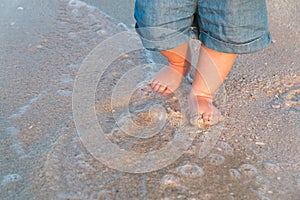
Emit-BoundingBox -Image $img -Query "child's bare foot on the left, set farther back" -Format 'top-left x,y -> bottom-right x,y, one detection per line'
150,66 -> 189,96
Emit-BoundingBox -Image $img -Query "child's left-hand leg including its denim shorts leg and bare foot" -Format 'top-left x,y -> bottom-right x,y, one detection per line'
134,0 -> 196,95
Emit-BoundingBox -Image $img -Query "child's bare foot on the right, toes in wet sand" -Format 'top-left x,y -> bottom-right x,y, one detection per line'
189,92 -> 223,127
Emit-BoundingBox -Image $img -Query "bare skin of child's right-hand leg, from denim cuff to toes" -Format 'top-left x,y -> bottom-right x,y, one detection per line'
189,45 -> 236,125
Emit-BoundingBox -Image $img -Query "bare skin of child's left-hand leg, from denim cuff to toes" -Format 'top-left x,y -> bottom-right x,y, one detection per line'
150,42 -> 190,95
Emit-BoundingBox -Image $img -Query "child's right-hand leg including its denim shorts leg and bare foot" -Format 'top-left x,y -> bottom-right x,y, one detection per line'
190,0 -> 271,125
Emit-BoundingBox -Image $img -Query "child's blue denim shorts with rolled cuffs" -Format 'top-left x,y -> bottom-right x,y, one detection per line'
134,0 -> 271,54
